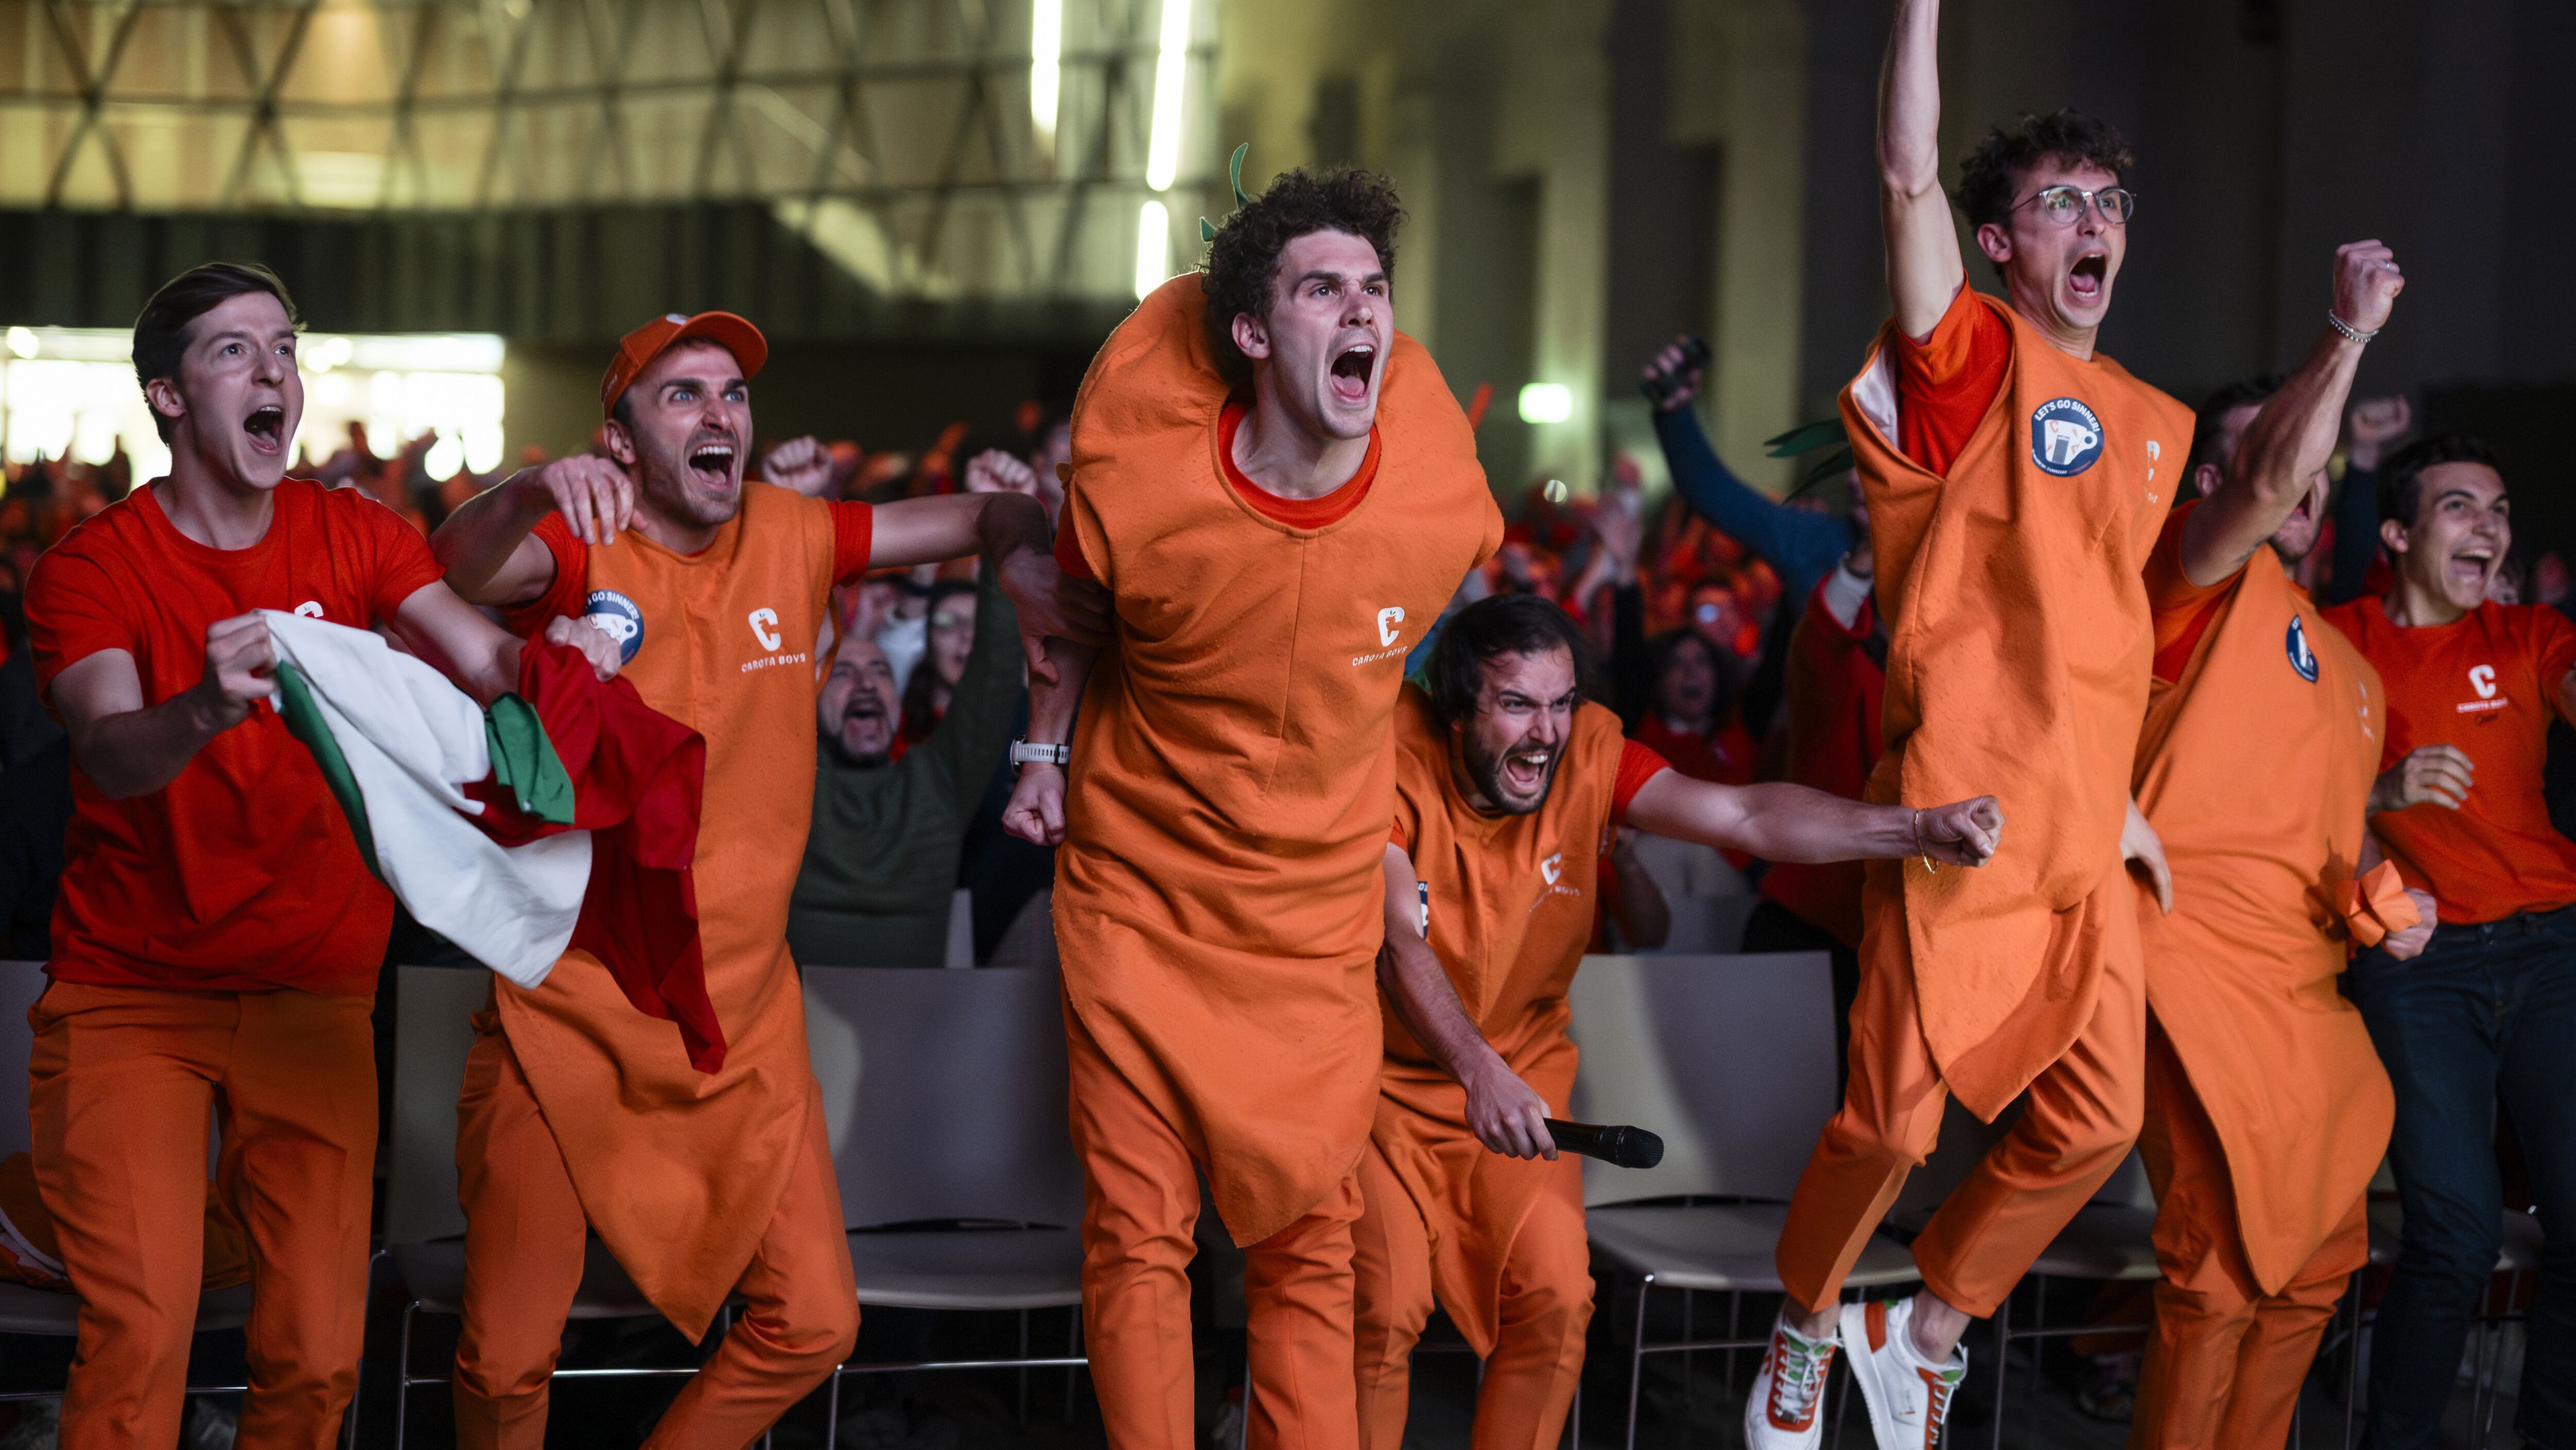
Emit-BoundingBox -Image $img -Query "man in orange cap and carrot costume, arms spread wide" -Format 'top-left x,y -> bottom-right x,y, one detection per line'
433,311 -> 1100,1450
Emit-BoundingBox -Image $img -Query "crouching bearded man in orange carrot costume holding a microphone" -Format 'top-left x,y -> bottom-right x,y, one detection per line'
1355,595 -> 2002,1450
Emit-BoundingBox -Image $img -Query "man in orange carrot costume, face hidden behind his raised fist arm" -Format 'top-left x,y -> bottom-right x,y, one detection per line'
2128,242 -> 2434,1450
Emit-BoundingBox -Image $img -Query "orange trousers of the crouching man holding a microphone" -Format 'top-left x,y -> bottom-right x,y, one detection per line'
1350,1143 -> 1592,1450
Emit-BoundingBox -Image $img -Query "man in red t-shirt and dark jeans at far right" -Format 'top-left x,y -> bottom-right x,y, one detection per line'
2326,435 -> 2576,1450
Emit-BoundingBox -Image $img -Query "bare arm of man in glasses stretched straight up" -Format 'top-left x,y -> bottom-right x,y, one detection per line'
1878,0 -> 1968,338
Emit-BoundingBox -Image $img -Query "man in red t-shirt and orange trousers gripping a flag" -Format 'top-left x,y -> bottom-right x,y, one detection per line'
25,263 -> 616,1447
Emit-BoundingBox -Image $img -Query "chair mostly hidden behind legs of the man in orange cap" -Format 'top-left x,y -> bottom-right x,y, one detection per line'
384,966 -> 767,1450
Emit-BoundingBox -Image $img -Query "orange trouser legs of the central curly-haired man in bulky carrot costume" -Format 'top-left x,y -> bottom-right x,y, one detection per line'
1064,1007 -> 1360,1450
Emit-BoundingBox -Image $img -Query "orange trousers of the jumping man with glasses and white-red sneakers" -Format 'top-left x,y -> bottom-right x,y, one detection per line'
1780,873 -> 2146,1318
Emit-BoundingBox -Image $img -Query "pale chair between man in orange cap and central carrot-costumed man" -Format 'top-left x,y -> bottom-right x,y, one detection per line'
804,966 -> 1089,1447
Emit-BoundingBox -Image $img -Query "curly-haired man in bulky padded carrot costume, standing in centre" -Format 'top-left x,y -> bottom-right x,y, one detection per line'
1005,172 -> 1502,1450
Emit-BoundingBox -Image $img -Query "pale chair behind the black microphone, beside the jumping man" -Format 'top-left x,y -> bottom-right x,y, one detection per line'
1569,953 -> 1917,1447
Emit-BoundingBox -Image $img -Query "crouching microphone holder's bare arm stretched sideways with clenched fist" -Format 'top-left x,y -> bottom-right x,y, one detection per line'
1628,770 -> 2004,866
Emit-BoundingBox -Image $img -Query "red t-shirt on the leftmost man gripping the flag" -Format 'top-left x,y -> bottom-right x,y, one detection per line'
25,479 -> 441,994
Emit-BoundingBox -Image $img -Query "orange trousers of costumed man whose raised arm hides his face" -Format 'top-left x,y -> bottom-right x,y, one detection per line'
2128,1033 -> 2370,1450
